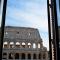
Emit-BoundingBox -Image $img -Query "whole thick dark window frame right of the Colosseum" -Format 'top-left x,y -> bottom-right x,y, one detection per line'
47,0 -> 60,60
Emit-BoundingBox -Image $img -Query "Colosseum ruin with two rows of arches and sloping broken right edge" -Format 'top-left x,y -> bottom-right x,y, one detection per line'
2,26 -> 48,60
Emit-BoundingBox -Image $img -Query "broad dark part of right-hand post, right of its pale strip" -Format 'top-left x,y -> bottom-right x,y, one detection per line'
51,0 -> 59,60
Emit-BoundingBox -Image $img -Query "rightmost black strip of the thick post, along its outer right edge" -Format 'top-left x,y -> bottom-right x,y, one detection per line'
54,0 -> 60,60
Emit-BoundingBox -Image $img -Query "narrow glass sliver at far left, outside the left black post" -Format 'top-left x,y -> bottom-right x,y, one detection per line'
0,0 -> 3,60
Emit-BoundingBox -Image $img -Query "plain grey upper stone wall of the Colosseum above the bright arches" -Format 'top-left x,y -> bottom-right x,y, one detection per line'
4,27 -> 42,41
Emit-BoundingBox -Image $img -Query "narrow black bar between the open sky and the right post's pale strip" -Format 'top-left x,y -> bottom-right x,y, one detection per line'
47,0 -> 52,60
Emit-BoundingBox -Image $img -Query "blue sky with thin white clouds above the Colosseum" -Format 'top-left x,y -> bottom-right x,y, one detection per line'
5,0 -> 49,50
